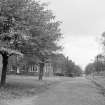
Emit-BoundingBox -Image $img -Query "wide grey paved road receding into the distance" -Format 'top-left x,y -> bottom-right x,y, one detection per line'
33,78 -> 105,105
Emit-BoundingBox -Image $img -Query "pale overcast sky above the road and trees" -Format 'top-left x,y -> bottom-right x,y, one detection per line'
41,0 -> 105,68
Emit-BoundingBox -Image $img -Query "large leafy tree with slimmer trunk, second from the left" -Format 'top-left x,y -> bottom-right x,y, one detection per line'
26,4 -> 62,80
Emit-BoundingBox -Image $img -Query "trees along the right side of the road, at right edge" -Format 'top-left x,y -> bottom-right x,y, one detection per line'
85,32 -> 105,75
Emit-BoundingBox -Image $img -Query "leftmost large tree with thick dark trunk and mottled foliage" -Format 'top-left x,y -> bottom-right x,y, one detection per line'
0,0 -> 31,86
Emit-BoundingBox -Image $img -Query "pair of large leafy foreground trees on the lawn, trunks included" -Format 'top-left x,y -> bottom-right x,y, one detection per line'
0,0 -> 62,86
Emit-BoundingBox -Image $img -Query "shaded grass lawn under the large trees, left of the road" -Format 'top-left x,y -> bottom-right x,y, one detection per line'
0,75 -> 59,105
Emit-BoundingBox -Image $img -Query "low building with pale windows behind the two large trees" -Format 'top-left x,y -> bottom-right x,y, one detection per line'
7,56 -> 54,76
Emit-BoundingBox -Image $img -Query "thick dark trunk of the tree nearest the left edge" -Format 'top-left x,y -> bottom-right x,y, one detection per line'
1,54 -> 8,86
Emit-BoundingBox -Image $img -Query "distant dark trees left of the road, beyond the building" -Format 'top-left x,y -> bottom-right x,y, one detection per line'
53,54 -> 82,77
